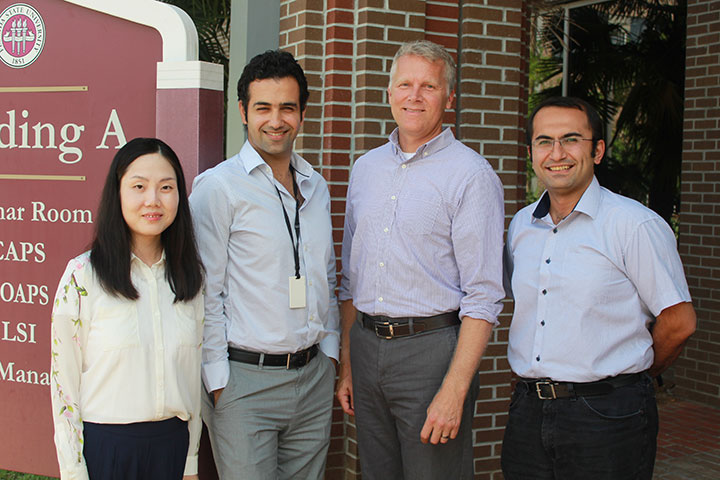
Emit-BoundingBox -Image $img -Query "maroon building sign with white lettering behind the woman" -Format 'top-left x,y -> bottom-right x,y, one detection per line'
0,0 -> 205,476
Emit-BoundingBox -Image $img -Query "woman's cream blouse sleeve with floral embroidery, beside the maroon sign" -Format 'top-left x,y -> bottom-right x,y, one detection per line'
50,257 -> 88,480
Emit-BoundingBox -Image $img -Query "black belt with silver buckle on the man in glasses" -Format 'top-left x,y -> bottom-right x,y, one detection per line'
518,372 -> 644,400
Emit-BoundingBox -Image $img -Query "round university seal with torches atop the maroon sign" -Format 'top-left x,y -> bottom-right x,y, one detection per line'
0,3 -> 45,68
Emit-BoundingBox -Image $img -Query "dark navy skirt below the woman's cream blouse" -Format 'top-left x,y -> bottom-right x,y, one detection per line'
83,417 -> 189,480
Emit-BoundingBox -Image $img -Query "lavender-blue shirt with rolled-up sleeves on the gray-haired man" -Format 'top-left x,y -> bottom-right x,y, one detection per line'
339,125 -> 504,324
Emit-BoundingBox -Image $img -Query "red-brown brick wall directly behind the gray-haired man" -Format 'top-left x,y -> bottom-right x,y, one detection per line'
280,0 -> 529,479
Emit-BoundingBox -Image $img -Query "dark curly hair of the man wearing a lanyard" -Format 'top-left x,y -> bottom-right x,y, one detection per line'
233,50 -> 310,112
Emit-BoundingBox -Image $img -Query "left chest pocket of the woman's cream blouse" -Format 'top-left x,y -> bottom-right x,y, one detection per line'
88,298 -> 140,350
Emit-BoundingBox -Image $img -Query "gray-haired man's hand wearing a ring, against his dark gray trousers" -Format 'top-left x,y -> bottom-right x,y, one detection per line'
420,383 -> 465,445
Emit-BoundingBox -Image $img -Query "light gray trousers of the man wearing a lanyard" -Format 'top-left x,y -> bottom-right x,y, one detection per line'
202,352 -> 335,480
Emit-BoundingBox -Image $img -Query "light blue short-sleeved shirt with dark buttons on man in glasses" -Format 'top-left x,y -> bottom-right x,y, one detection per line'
505,178 -> 690,382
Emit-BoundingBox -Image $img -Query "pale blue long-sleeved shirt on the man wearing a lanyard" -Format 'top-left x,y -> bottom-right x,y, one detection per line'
190,142 -> 340,391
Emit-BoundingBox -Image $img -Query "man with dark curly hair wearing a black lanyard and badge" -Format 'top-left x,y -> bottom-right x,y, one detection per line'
190,51 -> 339,479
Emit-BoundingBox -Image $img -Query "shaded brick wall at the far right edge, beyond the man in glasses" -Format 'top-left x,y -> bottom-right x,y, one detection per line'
674,0 -> 720,406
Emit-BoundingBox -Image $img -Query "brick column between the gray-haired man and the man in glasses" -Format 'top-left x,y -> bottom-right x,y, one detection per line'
458,0 -> 530,479
